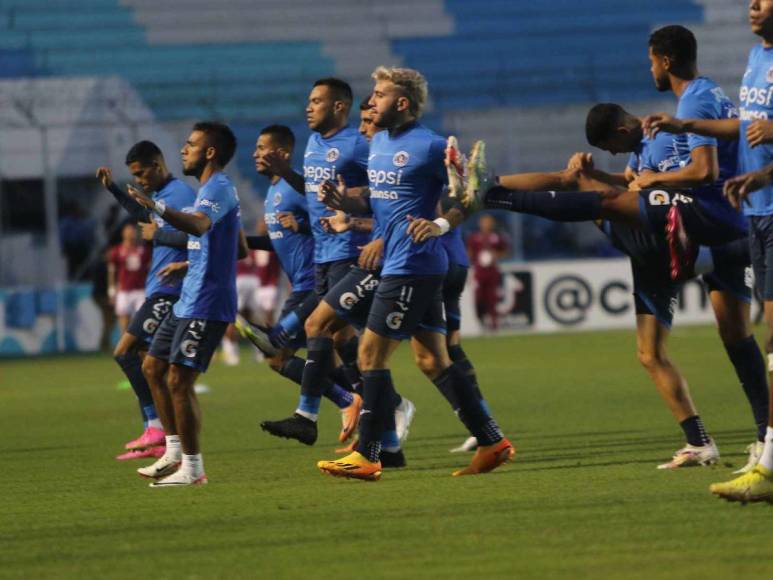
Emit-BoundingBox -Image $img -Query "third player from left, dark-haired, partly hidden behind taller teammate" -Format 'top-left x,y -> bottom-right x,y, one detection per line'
238,125 -> 362,445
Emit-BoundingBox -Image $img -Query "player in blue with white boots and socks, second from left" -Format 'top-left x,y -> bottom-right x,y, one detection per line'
129,122 -> 246,487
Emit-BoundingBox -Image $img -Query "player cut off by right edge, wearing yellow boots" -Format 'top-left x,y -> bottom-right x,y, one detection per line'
645,0 -> 773,502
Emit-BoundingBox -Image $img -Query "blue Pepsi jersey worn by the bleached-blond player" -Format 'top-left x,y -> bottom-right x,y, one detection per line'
368,123 -> 448,276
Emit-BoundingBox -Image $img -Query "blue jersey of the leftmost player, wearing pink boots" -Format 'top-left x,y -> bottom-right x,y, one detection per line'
145,177 -> 196,297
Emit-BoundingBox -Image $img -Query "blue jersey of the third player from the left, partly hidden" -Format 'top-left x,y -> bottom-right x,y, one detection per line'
264,179 -> 314,291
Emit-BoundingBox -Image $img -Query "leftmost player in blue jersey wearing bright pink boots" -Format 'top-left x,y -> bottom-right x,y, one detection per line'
97,141 -> 196,460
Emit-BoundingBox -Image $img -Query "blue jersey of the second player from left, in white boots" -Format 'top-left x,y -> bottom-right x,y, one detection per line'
174,173 -> 241,322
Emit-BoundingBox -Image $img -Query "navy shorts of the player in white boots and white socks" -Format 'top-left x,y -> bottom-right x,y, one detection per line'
148,312 -> 228,373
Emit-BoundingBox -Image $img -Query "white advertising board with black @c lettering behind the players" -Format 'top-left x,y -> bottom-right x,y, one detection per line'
462,258 -> 748,336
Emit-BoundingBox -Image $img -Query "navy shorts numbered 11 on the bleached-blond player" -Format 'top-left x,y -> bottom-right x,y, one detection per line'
367,275 -> 446,340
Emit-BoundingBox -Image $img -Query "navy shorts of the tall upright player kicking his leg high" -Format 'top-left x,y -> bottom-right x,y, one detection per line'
639,189 -> 748,246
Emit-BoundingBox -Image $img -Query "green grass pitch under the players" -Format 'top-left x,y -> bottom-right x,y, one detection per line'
0,328 -> 773,579
